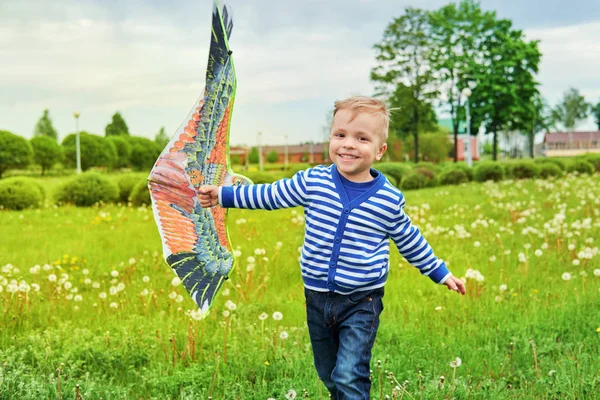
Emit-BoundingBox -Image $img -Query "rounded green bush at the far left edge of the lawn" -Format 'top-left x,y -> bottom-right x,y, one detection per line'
0,177 -> 44,210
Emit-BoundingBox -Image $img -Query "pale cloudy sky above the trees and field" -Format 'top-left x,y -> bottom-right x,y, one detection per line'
0,0 -> 600,144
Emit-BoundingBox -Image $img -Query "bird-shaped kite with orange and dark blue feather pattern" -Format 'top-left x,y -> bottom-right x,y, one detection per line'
148,0 -> 251,316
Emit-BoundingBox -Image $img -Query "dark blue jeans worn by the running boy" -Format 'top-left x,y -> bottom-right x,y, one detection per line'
304,288 -> 384,400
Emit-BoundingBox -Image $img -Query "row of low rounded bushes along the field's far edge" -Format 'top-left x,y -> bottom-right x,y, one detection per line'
0,154 -> 600,210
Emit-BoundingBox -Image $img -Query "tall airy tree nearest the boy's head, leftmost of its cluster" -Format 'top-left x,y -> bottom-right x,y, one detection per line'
371,7 -> 437,162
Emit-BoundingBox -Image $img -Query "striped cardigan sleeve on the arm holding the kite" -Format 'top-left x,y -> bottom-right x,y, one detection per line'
219,171 -> 308,210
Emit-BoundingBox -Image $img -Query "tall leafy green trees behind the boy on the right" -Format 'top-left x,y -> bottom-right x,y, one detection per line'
370,0 -> 600,162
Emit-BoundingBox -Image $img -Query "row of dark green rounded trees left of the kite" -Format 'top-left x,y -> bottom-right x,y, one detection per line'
0,109 -> 169,178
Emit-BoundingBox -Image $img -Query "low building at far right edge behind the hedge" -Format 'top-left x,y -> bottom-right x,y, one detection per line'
542,131 -> 600,157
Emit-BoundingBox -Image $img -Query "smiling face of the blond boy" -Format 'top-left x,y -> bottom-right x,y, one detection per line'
329,110 -> 387,182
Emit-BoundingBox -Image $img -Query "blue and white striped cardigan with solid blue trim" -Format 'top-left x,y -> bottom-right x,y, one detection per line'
219,165 -> 451,294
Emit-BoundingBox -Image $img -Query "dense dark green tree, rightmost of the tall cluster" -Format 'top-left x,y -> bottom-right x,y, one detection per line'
469,20 -> 541,160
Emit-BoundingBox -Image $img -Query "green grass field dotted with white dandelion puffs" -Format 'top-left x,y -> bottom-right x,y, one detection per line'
0,174 -> 600,400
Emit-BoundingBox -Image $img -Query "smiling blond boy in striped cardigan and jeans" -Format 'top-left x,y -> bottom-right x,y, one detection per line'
198,97 -> 465,399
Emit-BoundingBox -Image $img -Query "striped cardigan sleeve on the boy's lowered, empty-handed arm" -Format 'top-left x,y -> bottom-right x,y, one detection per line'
390,196 -> 452,283
